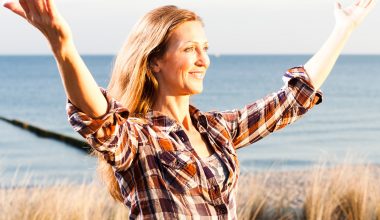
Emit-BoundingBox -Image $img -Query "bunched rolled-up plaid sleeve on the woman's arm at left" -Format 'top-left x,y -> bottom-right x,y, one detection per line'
66,88 -> 138,170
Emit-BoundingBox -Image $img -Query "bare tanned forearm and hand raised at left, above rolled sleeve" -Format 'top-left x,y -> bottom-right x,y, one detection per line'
4,0 -> 107,118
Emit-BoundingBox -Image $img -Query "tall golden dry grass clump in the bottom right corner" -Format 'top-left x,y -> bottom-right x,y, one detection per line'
304,165 -> 380,220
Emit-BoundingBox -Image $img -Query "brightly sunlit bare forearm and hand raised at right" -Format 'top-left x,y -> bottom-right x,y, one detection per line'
304,0 -> 375,89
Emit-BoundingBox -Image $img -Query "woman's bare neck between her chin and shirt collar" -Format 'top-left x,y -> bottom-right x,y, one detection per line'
153,96 -> 192,131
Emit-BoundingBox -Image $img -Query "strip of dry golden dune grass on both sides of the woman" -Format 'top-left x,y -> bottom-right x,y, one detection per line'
0,161 -> 380,220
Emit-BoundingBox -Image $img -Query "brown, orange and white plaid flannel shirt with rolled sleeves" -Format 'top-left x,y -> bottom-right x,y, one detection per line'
67,67 -> 322,219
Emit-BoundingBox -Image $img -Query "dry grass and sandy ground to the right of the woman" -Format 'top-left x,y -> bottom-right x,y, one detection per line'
238,163 -> 380,220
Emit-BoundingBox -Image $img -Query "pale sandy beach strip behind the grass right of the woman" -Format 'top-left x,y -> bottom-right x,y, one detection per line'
238,165 -> 380,210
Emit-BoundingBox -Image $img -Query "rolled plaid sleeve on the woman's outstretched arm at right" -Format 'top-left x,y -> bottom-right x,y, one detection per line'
221,67 -> 322,149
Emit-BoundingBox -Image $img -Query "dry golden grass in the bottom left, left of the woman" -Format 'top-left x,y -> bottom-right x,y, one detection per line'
0,183 -> 128,220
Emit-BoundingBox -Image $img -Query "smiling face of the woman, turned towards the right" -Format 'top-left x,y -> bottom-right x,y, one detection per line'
153,21 -> 210,96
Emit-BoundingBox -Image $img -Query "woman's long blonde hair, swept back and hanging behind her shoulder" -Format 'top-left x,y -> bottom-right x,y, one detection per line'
97,6 -> 202,202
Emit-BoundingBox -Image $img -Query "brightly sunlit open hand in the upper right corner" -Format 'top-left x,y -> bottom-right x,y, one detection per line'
335,0 -> 376,30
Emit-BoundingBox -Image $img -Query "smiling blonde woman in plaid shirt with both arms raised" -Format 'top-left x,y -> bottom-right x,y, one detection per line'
5,0 -> 374,219
